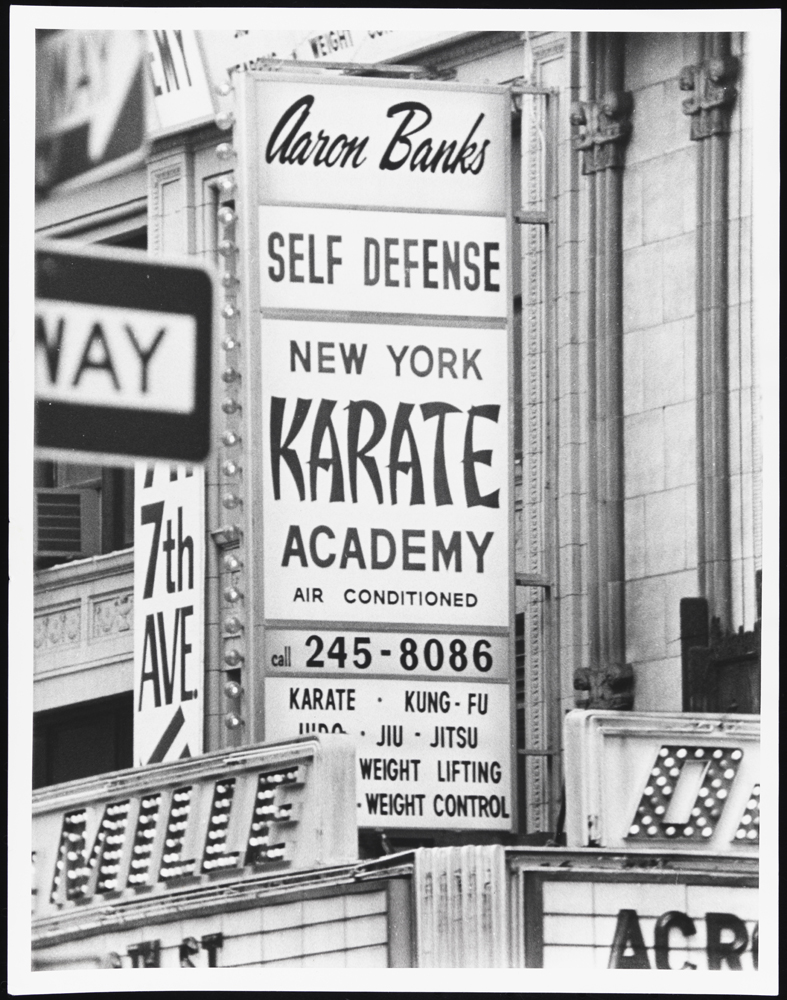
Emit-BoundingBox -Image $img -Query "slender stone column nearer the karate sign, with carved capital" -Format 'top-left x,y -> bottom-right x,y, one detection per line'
571,34 -> 632,709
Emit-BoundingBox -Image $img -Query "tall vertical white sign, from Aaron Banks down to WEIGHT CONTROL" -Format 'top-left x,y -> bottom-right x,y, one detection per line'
235,74 -> 515,830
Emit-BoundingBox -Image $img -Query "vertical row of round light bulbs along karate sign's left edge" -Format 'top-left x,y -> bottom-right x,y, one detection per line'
216,90 -> 245,732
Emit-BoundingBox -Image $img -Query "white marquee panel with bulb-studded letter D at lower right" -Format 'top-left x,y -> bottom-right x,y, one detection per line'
564,710 -> 760,855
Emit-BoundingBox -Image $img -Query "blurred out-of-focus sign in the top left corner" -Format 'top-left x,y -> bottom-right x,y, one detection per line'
36,29 -> 146,189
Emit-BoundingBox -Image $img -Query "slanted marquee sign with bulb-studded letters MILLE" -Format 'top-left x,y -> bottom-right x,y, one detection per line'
33,736 -> 357,919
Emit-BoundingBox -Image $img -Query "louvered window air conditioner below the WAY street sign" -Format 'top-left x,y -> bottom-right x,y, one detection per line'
35,487 -> 101,560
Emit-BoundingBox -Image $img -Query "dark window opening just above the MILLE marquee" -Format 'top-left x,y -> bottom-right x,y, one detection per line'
33,691 -> 134,788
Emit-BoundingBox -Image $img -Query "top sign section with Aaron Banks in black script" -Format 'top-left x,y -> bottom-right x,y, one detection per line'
243,79 -> 506,215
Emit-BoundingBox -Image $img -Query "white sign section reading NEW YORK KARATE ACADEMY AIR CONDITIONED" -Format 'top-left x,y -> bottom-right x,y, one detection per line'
262,319 -> 509,629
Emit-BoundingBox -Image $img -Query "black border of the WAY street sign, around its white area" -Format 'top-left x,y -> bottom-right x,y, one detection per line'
35,241 -> 216,465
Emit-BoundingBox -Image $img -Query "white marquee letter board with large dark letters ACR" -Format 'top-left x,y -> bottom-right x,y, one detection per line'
524,872 -> 759,972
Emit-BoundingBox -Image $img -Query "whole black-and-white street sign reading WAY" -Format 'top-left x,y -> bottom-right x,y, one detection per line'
35,242 -> 214,464
